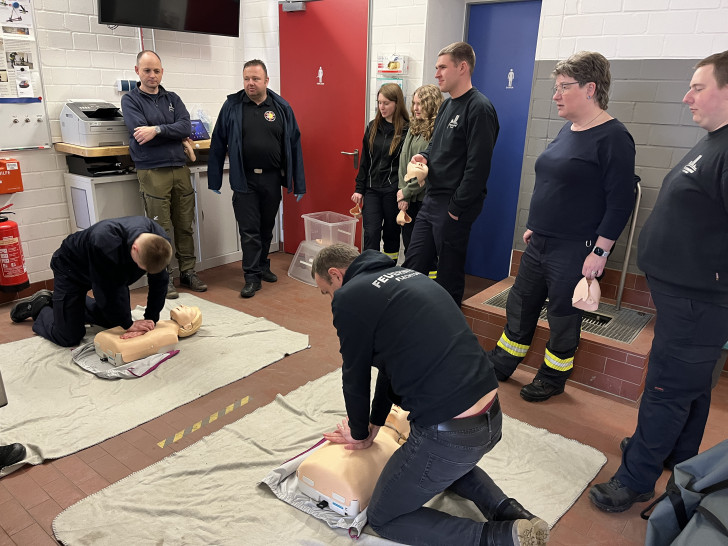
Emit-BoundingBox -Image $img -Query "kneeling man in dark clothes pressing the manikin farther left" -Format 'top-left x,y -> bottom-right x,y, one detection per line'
10,216 -> 172,347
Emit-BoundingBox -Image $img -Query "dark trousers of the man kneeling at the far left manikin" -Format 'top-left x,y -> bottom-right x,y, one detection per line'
33,272 -> 118,347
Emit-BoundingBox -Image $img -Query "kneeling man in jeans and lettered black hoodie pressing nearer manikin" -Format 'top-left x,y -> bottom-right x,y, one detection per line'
312,244 -> 548,546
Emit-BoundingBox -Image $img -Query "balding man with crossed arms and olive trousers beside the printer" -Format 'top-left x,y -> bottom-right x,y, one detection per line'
121,50 -> 207,299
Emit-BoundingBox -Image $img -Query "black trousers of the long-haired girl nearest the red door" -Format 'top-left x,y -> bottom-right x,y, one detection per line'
361,186 -> 401,254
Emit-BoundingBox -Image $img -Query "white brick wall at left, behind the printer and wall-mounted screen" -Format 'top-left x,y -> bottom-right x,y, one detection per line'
0,0 -> 280,282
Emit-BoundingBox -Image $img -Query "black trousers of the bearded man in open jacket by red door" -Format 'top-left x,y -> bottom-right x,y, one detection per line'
233,170 -> 283,282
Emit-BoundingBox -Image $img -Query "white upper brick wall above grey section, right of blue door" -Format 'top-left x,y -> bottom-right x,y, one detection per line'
536,0 -> 728,60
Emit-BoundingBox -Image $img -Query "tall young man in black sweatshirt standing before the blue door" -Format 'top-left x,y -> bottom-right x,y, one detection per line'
402,42 -> 499,306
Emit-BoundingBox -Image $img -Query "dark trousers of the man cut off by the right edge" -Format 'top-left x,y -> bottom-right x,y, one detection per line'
615,288 -> 728,493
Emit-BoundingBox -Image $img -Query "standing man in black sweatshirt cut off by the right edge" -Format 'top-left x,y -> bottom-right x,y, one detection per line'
589,51 -> 728,512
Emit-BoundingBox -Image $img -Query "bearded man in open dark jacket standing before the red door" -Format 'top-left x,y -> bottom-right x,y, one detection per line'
207,59 -> 306,298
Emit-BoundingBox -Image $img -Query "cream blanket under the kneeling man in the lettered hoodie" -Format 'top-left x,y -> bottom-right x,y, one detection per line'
53,371 -> 606,546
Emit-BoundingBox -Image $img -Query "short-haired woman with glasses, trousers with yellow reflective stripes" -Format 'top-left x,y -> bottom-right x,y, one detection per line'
489,51 -> 635,402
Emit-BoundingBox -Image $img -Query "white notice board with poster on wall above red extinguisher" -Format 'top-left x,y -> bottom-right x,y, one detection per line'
0,0 -> 51,150
